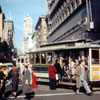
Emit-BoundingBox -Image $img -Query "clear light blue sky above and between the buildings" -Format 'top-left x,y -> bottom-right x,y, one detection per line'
0,0 -> 46,48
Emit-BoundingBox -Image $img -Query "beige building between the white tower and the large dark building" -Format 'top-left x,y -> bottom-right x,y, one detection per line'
35,16 -> 47,47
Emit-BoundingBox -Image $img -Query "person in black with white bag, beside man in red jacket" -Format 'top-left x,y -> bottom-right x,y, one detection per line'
54,59 -> 62,85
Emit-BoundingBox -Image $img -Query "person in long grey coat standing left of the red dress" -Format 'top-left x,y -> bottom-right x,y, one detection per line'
22,65 -> 31,100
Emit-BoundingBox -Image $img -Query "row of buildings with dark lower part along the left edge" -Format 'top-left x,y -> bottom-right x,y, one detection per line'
0,6 -> 17,63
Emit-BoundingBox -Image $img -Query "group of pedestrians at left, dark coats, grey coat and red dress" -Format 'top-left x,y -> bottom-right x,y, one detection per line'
0,65 -> 38,100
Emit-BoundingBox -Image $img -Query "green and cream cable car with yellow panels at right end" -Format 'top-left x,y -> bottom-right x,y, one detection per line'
28,40 -> 100,84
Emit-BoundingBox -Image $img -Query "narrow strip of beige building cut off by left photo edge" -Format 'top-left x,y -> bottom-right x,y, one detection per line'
0,6 -> 5,40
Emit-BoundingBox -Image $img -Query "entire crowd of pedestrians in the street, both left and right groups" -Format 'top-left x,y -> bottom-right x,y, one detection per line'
0,56 -> 92,99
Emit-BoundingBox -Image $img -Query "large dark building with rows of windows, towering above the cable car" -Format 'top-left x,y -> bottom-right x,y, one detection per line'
46,0 -> 100,43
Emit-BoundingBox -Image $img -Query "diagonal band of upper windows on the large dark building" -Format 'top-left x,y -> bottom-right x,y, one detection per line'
49,0 -> 82,32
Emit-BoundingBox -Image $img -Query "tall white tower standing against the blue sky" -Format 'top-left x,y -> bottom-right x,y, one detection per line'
24,16 -> 32,54
